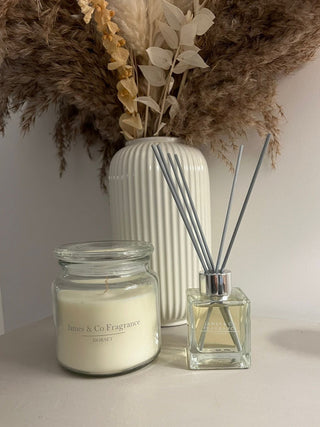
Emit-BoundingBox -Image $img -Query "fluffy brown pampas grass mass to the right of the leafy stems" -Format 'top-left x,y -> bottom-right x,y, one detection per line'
167,0 -> 320,163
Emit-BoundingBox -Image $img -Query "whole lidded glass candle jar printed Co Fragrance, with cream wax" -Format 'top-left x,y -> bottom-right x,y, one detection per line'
52,241 -> 160,375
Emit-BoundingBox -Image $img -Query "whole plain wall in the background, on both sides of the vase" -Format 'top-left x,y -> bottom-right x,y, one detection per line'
0,56 -> 320,330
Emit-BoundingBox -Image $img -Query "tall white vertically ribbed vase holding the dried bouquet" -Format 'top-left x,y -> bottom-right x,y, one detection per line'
109,137 -> 211,326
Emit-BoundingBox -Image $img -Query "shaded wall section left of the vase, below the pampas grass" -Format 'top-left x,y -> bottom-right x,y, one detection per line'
0,111 -> 110,331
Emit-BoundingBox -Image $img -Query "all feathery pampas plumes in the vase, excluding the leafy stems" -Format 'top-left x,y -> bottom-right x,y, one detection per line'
0,0 -> 320,185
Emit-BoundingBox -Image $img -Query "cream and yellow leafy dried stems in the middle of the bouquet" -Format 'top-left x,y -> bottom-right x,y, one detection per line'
78,0 -> 214,139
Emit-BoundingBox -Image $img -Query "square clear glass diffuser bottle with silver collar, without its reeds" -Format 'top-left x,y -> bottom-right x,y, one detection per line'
187,271 -> 250,369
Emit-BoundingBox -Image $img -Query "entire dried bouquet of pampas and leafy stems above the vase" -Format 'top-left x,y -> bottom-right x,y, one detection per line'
0,0 -> 320,185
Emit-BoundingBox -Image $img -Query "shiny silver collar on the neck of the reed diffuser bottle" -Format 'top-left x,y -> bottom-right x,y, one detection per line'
199,270 -> 231,297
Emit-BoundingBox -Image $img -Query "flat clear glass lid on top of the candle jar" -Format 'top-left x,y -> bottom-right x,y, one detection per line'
54,240 -> 153,262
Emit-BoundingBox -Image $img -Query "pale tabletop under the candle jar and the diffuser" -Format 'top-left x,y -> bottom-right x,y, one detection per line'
0,318 -> 320,427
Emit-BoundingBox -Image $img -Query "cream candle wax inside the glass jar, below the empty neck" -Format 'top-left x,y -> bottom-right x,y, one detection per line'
56,285 -> 159,375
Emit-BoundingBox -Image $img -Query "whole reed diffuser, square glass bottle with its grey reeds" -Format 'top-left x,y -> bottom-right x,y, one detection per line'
152,134 -> 270,369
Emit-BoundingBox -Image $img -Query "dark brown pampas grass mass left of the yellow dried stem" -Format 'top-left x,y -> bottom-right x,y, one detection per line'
0,0 -> 123,186
